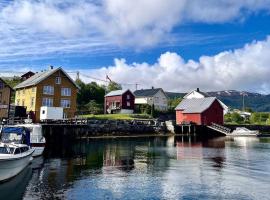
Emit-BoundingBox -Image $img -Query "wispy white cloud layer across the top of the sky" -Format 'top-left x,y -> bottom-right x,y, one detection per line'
0,0 -> 270,53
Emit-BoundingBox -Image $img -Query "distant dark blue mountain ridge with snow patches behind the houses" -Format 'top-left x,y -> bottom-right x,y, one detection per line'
166,90 -> 270,112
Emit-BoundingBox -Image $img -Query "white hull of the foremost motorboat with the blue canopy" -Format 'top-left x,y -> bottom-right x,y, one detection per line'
0,150 -> 34,182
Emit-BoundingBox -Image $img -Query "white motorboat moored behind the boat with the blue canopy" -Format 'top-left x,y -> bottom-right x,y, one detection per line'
16,124 -> 46,157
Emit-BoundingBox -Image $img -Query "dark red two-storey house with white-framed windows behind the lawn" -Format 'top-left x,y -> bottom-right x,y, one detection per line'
104,90 -> 135,114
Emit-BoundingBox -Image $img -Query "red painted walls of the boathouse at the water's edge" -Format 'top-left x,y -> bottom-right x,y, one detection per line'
176,100 -> 224,125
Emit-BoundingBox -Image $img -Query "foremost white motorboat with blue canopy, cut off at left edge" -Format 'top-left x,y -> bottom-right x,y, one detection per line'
0,127 -> 34,181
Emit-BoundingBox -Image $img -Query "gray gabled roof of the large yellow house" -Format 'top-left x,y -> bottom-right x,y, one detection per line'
14,67 -> 79,89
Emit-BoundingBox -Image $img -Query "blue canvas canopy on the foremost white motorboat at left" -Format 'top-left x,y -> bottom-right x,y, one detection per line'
1,127 -> 30,146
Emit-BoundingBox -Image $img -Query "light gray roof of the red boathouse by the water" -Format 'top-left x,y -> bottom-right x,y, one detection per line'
175,97 -> 219,113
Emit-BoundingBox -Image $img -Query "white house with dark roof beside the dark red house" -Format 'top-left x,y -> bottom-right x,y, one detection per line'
133,88 -> 169,111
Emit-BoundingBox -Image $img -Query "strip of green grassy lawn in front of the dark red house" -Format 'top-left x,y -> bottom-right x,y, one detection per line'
80,114 -> 151,120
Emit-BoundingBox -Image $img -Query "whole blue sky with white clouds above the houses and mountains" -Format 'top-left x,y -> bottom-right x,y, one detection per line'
0,0 -> 270,94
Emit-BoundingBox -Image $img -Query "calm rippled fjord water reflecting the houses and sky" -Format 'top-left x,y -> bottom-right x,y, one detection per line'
0,137 -> 270,199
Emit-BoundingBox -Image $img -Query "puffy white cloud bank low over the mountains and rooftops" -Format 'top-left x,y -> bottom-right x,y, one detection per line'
88,37 -> 270,93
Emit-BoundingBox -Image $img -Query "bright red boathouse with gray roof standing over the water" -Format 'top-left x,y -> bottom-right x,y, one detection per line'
175,97 -> 223,125
